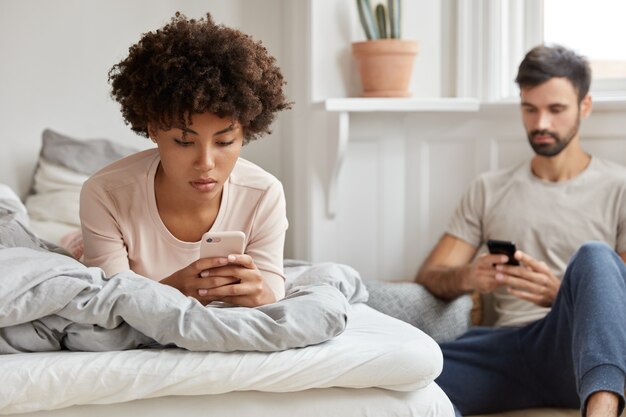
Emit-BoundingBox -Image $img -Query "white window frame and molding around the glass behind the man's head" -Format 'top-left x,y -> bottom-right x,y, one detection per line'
456,0 -> 626,102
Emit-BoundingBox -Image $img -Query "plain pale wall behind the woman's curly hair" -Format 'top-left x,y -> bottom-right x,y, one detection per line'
0,0 -> 283,196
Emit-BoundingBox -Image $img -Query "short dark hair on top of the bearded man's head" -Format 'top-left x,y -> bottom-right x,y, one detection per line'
515,45 -> 591,103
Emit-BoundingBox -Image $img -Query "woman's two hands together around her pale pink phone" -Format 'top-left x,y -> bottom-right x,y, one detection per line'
161,255 -> 276,307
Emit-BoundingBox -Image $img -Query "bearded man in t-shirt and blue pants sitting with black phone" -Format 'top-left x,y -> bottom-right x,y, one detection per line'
416,46 -> 626,416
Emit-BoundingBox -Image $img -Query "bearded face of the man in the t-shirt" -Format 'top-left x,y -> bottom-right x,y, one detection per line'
520,78 -> 591,157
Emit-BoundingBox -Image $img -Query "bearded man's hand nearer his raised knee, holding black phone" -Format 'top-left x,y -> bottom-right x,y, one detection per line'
495,250 -> 561,307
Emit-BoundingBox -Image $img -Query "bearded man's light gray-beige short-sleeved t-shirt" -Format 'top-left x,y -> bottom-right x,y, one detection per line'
446,157 -> 626,326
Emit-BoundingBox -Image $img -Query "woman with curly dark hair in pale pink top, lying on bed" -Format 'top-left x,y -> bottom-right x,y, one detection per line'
80,13 -> 290,306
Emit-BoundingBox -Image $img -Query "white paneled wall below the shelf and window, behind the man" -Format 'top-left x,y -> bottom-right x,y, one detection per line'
311,104 -> 626,281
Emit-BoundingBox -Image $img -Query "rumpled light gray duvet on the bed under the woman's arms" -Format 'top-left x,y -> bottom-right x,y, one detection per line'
0,199 -> 367,353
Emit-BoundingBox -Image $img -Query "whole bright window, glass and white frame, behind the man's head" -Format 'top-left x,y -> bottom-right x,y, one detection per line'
456,0 -> 626,102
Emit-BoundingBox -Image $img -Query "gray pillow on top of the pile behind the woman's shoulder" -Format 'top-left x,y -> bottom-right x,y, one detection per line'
41,129 -> 138,175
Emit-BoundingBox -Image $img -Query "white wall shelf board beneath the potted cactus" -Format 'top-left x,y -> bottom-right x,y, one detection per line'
324,97 -> 480,112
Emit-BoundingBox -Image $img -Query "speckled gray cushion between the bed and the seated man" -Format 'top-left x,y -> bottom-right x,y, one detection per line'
365,281 -> 472,343
